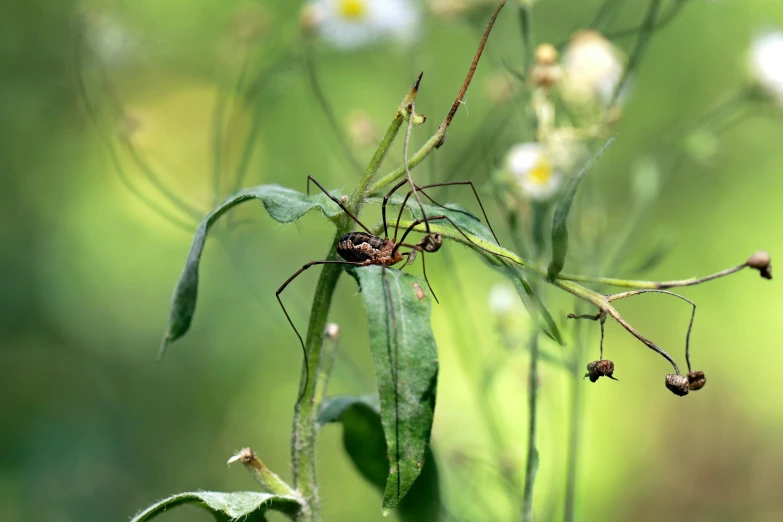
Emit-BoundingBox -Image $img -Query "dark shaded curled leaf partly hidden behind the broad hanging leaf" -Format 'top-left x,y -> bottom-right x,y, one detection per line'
318,395 -> 440,522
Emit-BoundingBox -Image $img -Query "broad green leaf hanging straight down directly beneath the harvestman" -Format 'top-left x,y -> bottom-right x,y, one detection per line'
349,266 -> 438,513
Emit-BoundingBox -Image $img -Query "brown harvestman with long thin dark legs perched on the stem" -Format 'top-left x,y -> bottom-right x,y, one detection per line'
275,176 -> 500,390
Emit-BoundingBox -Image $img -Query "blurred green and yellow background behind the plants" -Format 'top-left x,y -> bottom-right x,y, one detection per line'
0,0 -> 783,522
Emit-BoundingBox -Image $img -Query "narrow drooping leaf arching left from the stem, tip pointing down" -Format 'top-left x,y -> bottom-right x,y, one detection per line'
159,185 -> 342,357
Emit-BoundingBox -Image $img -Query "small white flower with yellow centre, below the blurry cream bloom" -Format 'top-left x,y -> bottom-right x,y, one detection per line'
505,142 -> 561,201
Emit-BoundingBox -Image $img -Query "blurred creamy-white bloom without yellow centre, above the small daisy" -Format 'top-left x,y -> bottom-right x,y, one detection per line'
562,30 -> 624,106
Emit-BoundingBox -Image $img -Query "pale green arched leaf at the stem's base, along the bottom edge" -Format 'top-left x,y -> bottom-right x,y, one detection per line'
131,491 -> 301,522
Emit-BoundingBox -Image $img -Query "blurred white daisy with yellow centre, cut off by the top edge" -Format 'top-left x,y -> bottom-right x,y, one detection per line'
306,0 -> 421,49
